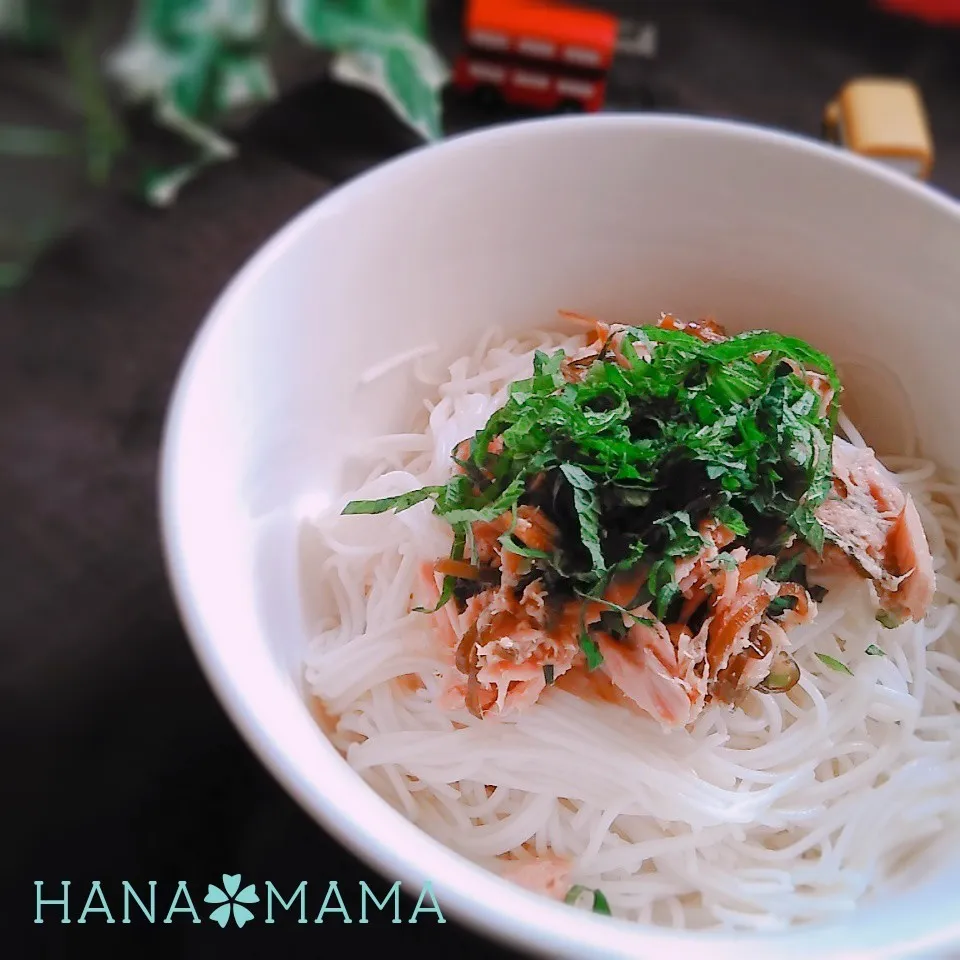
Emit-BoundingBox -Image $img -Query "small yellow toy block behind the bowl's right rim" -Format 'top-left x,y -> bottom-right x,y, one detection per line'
823,77 -> 933,180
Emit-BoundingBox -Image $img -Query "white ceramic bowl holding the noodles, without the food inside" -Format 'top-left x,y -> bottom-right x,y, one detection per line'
161,116 -> 960,960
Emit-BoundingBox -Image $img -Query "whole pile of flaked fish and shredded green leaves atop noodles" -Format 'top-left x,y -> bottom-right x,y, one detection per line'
344,314 -> 933,726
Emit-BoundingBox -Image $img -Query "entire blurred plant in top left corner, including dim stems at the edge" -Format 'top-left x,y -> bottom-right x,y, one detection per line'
0,0 -> 448,287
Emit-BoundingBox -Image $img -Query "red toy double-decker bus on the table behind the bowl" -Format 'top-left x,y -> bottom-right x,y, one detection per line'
453,0 -> 620,112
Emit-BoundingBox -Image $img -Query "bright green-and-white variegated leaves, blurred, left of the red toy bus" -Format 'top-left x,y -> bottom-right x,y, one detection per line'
109,0 -> 448,206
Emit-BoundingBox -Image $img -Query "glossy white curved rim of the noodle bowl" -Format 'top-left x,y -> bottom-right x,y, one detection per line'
157,113 -> 960,960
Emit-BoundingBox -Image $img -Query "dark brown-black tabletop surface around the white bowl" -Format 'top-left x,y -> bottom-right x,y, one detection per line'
0,0 -> 960,958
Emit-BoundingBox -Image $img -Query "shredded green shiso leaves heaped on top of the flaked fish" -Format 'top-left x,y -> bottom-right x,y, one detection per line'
343,326 -> 840,624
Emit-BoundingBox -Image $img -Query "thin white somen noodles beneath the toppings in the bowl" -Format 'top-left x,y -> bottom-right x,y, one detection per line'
306,333 -> 960,929
